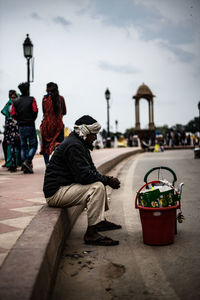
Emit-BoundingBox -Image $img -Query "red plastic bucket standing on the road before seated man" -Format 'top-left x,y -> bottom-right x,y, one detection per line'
135,181 -> 180,245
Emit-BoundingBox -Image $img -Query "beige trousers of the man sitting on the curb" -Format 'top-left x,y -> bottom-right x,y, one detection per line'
46,181 -> 108,226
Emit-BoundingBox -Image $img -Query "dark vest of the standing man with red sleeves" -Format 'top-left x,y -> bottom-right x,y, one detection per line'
13,96 -> 38,126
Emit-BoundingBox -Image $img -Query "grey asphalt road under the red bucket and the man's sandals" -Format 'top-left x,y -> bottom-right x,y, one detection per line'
52,150 -> 200,300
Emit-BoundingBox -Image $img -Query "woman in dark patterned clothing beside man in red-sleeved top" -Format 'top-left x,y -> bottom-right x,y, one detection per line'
5,91 -> 20,172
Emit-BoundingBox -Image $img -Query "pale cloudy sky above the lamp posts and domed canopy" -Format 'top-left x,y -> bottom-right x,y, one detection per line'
0,0 -> 200,132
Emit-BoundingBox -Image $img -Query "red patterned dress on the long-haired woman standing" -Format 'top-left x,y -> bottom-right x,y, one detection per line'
40,96 -> 63,155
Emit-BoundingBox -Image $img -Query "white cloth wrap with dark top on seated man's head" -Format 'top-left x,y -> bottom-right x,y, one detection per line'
74,115 -> 101,140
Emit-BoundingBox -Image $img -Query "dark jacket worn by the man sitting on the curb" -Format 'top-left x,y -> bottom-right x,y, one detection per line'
43,132 -> 108,198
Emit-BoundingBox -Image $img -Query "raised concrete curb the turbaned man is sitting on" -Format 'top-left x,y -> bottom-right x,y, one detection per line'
0,149 -> 142,300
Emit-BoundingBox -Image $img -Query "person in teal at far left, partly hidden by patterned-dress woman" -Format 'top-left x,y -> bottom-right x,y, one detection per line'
1,90 -> 15,167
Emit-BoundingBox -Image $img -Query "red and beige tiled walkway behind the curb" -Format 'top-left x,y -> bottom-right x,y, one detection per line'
0,148 -> 138,266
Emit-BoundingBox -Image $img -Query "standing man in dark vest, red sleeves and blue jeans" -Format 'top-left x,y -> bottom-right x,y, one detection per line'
11,82 -> 38,173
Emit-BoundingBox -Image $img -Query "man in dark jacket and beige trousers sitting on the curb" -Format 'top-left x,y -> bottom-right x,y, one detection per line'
43,115 -> 121,246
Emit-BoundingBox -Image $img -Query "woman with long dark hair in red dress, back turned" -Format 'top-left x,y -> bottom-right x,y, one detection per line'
40,82 -> 66,165
